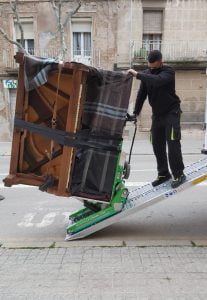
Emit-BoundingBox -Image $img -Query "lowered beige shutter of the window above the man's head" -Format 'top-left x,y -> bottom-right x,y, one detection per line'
143,10 -> 163,33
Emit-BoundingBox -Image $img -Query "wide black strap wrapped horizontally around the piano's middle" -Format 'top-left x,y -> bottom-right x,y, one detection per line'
14,119 -> 122,152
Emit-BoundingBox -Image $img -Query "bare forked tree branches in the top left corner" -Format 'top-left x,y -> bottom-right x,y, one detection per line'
0,0 -> 28,54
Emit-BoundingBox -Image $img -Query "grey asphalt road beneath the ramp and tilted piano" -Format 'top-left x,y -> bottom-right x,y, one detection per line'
0,154 -> 207,247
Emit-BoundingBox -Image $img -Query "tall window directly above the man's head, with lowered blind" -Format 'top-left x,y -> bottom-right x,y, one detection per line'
143,10 -> 163,51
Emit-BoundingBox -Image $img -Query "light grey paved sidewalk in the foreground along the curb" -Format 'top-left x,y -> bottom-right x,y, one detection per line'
0,247 -> 207,300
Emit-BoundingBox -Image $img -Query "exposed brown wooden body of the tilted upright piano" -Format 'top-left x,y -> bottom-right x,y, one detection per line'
4,53 -> 88,196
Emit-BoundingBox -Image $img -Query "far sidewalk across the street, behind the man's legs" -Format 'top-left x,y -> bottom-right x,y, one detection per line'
0,130 -> 204,156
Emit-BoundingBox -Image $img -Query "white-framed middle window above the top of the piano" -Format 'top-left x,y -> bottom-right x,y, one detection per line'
72,18 -> 91,65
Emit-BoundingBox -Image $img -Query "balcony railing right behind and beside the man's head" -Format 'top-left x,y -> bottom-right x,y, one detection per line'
130,40 -> 207,62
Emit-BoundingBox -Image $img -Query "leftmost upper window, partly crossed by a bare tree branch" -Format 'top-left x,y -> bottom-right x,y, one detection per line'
14,18 -> 34,54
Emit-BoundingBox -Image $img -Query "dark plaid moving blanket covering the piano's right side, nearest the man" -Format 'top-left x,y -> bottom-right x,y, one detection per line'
71,68 -> 132,202
